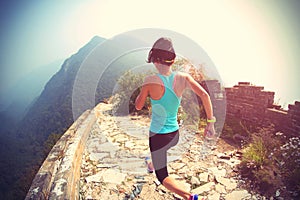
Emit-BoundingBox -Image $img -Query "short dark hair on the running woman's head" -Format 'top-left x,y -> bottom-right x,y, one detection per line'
147,37 -> 176,66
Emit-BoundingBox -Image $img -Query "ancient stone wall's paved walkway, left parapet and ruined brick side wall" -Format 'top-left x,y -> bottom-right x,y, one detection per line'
26,81 -> 300,200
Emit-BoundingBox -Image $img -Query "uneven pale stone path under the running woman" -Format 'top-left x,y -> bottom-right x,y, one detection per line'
80,104 -> 264,200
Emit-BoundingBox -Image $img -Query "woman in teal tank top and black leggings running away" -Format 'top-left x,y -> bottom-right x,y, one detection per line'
135,38 -> 216,200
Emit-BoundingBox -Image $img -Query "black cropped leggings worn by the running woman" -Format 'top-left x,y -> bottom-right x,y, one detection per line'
149,130 -> 179,183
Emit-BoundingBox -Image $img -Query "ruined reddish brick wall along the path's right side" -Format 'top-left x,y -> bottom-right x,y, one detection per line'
201,80 -> 300,135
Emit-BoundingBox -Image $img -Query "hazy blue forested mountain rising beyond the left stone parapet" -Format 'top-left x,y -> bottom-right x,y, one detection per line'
0,36 -> 150,199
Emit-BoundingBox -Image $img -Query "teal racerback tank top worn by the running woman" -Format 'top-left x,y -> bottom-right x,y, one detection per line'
150,72 -> 181,134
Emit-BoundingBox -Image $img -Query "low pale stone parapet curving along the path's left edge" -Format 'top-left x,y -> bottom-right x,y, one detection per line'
25,110 -> 96,200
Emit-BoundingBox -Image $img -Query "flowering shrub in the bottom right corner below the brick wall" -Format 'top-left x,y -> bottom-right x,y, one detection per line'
239,126 -> 300,199
